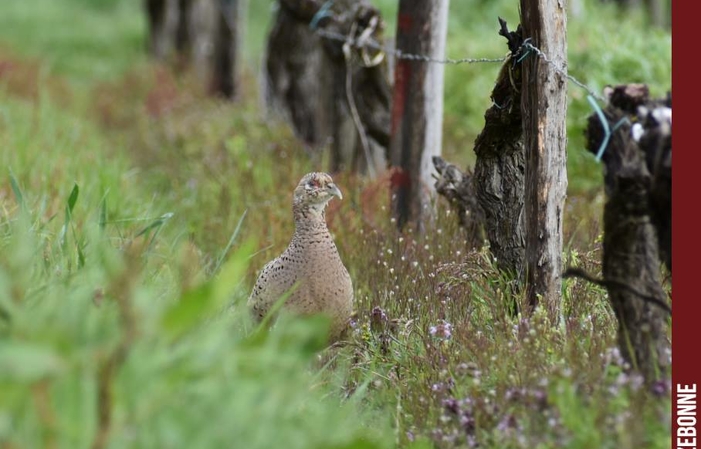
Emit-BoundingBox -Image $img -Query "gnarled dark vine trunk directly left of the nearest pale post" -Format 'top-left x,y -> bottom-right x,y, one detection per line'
433,18 -> 526,279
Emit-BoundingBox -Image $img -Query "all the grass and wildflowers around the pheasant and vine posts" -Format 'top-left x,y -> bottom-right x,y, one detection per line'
0,0 -> 670,449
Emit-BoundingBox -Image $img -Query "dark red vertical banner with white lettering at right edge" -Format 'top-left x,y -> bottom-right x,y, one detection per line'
671,2 -> 701,448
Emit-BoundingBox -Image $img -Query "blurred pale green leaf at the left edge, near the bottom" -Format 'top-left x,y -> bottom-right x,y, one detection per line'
0,342 -> 62,382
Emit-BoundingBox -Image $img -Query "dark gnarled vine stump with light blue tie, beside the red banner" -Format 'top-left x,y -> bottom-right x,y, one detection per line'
575,84 -> 672,383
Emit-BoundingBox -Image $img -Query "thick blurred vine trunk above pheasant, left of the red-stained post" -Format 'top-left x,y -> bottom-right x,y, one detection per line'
265,0 -> 391,170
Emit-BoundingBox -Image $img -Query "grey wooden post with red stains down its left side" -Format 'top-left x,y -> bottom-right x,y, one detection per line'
390,0 -> 448,230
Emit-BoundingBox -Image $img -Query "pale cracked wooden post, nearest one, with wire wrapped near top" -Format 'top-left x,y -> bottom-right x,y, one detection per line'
521,0 -> 567,322
